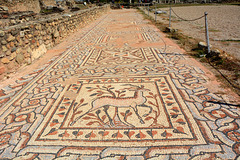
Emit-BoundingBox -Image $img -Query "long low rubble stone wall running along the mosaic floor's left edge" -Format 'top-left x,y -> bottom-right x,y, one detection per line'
0,5 -> 109,79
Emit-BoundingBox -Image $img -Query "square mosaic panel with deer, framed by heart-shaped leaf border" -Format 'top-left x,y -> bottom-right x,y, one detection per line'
28,76 -> 206,147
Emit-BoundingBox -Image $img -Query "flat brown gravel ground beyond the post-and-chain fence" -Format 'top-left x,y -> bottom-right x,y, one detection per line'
155,5 -> 240,60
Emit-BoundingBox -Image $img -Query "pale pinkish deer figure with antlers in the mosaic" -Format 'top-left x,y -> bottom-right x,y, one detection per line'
70,84 -> 152,126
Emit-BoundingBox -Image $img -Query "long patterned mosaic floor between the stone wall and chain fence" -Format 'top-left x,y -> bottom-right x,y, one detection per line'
0,9 -> 240,160
